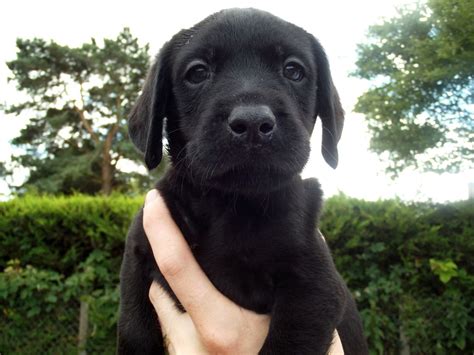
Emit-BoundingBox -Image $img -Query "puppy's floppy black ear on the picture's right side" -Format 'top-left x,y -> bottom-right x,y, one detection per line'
315,40 -> 344,169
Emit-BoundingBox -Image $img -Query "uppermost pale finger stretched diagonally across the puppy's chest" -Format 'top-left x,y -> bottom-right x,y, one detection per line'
143,193 -> 230,326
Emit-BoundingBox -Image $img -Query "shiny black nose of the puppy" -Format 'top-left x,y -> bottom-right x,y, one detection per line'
228,105 -> 276,143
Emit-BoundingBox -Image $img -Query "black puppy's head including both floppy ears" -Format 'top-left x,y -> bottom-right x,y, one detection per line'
129,9 -> 344,192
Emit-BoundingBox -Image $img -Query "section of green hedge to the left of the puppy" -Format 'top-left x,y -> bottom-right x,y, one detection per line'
0,195 -> 143,354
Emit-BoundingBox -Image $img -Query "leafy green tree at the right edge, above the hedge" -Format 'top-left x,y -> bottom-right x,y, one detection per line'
354,0 -> 474,174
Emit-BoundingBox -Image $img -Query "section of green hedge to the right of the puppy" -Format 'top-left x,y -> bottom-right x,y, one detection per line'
321,196 -> 474,354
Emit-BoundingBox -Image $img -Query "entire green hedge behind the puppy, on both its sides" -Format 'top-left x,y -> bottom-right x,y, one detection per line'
0,195 -> 474,354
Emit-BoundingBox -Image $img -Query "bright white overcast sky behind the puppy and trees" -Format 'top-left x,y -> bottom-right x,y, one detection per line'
0,0 -> 474,202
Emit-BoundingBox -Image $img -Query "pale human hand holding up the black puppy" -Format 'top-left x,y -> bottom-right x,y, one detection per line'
143,190 -> 343,354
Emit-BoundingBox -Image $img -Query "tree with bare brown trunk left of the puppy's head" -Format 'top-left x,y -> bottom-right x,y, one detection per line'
3,28 -> 164,194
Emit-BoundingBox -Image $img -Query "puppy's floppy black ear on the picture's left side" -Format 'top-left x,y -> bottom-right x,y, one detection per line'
128,45 -> 170,170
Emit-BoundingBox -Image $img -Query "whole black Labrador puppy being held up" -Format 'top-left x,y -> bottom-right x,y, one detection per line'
118,9 -> 367,354
